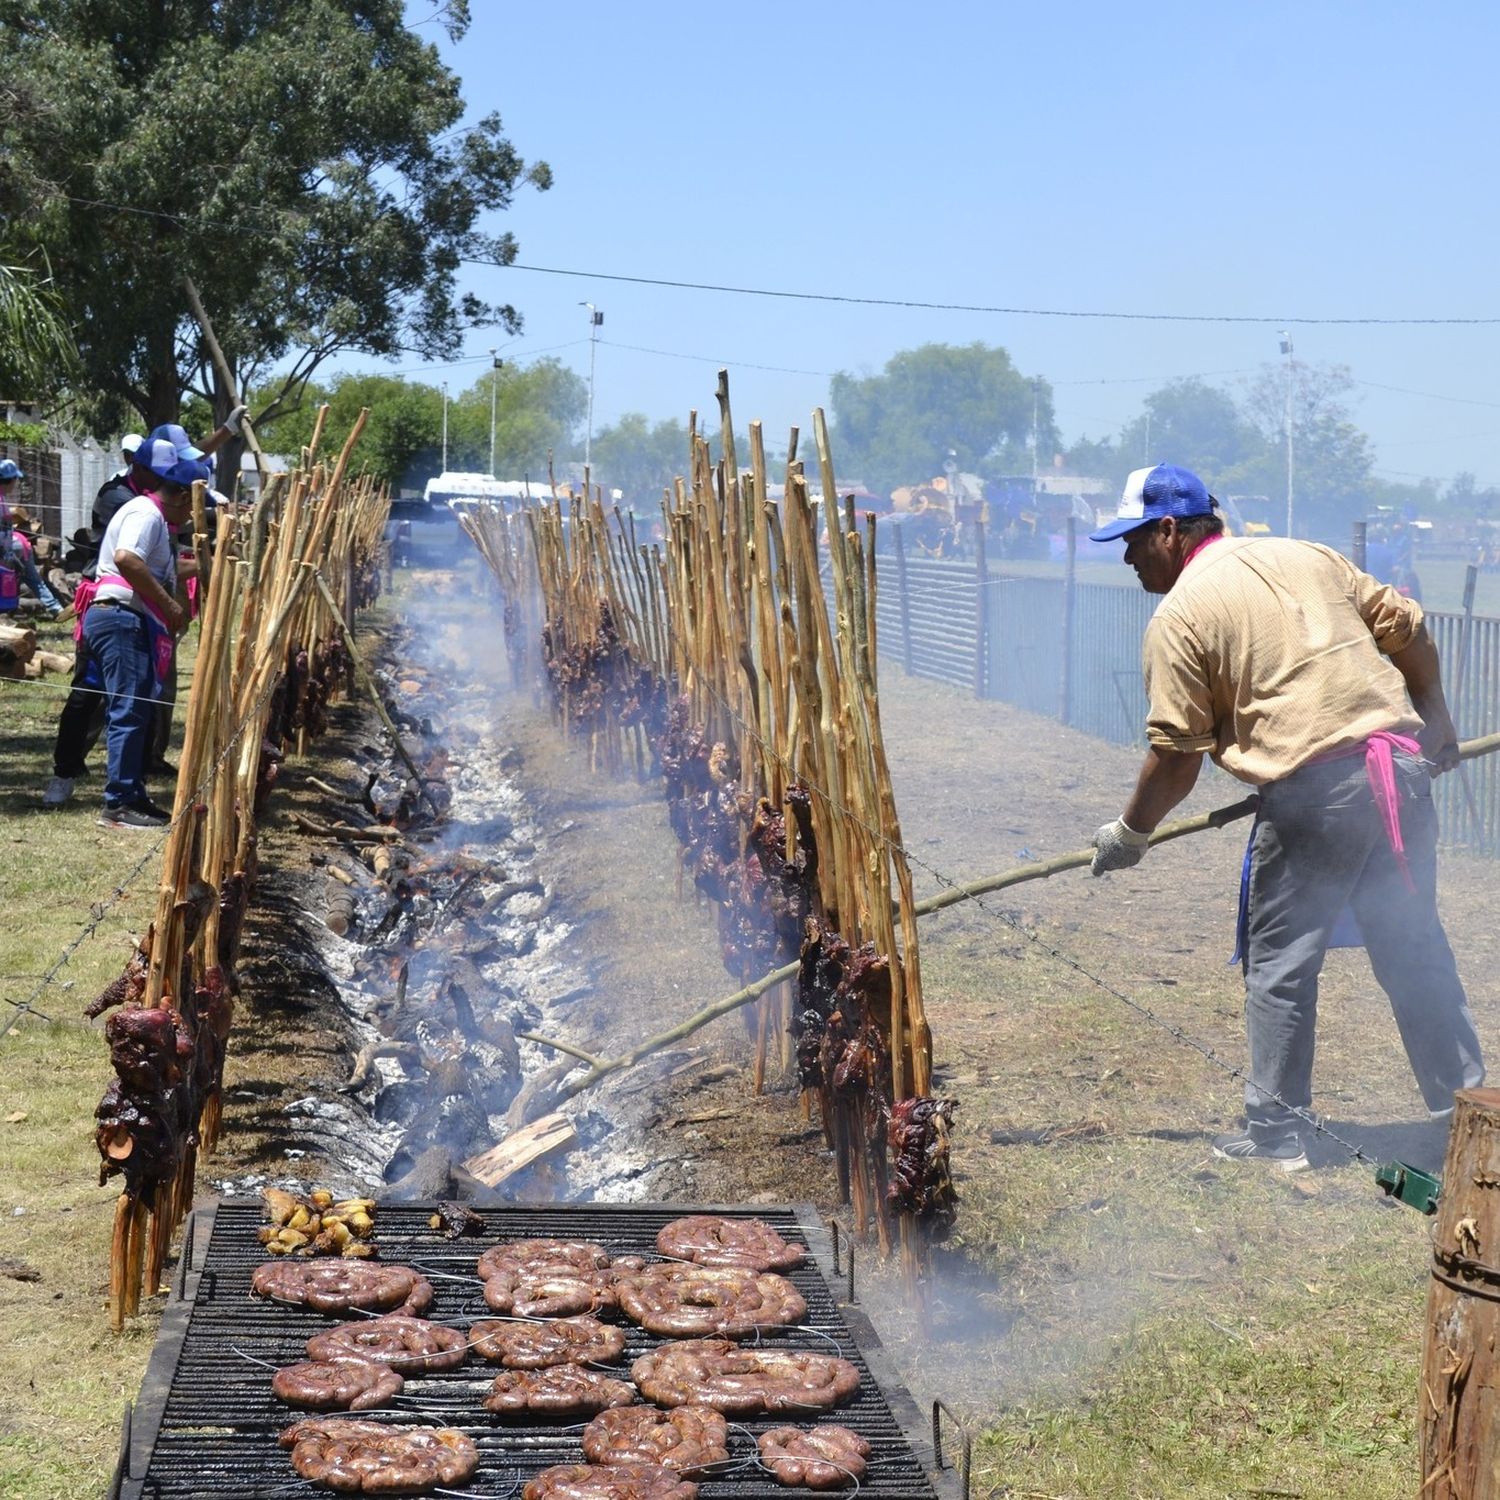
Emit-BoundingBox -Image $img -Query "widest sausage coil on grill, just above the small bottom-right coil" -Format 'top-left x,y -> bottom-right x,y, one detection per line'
630,1338 -> 860,1413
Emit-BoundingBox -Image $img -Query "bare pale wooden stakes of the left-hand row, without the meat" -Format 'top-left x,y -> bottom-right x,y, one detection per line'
101,408 -> 390,1329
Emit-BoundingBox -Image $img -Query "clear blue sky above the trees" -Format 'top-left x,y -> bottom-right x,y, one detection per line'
381,0 -> 1500,483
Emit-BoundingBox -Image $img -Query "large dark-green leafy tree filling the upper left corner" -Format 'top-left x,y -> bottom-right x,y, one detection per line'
0,0 -> 551,483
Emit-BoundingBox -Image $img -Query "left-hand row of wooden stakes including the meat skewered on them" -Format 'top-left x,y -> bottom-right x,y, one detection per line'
87,417 -> 389,1328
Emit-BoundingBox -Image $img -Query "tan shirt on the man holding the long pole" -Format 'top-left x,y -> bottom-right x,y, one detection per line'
1142,537 -> 1422,786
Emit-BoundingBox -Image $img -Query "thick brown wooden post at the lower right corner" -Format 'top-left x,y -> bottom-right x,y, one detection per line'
1421,1089 -> 1500,1500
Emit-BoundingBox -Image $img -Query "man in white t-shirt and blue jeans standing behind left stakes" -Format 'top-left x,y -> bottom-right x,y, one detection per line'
84,435 -> 209,828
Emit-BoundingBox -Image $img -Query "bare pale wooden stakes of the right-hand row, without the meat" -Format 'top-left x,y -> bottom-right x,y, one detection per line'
464,372 -> 932,1272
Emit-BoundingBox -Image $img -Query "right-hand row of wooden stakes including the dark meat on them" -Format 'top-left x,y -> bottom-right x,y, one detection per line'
464,372 -> 956,1272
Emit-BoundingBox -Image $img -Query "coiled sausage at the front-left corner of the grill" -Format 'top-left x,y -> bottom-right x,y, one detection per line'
281,1418 -> 479,1494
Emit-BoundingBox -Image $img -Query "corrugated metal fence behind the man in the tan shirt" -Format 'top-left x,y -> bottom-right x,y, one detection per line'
858,546 -> 1500,860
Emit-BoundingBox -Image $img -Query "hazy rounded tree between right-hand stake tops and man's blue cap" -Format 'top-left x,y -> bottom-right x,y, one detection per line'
830,344 -> 1058,491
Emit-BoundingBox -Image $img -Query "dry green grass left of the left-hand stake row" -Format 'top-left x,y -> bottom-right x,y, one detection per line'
0,623 -> 197,1500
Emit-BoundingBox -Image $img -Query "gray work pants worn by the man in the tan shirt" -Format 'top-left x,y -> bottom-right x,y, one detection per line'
1245,752 -> 1485,1136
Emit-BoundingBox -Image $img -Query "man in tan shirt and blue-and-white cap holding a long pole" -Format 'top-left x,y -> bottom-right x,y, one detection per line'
1092,464 -> 1485,1172
